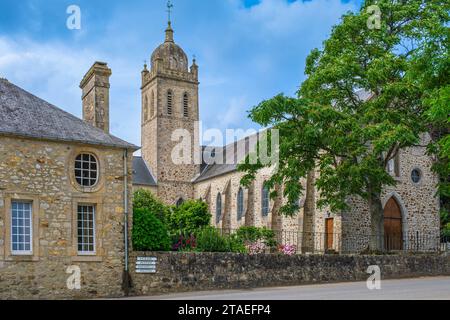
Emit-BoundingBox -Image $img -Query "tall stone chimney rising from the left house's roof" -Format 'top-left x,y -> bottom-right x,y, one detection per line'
80,62 -> 112,133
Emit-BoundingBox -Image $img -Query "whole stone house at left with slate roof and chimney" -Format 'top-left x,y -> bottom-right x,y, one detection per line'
0,62 -> 138,299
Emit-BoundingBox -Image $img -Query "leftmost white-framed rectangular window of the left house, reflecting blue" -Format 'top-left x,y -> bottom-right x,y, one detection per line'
11,201 -> 33,255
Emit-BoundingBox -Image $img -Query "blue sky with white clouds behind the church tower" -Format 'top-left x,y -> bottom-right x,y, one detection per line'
0,0 -> 361,145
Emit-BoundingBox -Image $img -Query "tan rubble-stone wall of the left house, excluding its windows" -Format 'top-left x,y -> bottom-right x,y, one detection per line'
0,136 -> 131,299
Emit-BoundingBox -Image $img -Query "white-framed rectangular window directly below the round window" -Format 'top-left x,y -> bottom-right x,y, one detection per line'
77,205 -> 95,254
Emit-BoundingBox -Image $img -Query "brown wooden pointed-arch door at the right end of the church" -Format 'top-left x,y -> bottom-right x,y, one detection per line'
384,197 -> 403,251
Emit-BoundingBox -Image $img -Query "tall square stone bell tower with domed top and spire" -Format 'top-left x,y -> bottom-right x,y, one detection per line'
141,2 -> 200,204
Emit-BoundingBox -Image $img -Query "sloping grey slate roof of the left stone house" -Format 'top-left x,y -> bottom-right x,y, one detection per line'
0,79 -> 139,150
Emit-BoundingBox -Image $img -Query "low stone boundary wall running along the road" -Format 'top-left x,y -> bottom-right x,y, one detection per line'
130,252 -> 450,295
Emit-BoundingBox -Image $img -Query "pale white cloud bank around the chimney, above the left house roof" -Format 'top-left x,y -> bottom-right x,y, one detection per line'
0,37 -> 140,144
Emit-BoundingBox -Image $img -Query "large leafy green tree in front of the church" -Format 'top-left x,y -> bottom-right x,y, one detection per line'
239,0 -> 450,248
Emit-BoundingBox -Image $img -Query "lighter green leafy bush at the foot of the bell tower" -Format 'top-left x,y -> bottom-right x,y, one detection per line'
167,200 -> 211,235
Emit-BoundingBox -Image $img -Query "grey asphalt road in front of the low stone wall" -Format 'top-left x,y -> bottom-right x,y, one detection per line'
125,277 -> 450,301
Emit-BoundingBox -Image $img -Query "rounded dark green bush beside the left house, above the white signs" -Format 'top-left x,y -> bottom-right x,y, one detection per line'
132,208 -> 171,251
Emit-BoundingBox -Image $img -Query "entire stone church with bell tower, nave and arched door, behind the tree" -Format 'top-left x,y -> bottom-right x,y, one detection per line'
134,22 -> 439,252
